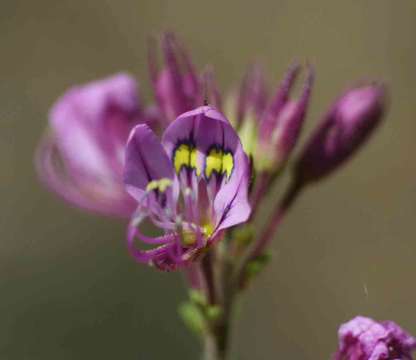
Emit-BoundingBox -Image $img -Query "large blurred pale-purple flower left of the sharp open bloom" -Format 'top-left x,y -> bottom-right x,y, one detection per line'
37,74 -> 141,217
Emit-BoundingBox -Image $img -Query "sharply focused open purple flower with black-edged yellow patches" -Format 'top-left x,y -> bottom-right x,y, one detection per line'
124,106 -> 250,270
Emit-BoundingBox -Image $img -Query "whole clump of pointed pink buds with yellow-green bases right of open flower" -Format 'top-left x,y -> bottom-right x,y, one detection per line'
229,65 -> 313,171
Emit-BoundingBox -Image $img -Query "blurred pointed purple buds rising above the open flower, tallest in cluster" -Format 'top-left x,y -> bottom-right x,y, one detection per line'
149,33 -> 203,123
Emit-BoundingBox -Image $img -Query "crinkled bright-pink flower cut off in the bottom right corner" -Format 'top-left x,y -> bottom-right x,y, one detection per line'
334,316 -> 416,360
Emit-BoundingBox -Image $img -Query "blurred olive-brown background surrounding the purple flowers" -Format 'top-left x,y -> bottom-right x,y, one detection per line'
0,0 -> 416,360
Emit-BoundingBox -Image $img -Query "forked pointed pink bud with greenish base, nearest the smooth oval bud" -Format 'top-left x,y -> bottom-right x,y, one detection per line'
256,65 -> 314,170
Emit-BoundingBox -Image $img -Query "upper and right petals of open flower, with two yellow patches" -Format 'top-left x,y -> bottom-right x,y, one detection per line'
162,106 -> 251,229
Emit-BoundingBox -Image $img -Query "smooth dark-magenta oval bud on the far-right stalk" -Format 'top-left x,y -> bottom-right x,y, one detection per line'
296,85 -> 385,186
